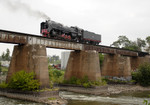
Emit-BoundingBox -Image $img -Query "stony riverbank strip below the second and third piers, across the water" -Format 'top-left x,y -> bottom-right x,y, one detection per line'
59,84 -> 150,96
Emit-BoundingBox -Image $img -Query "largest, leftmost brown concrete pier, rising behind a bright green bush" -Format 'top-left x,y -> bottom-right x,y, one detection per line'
6,44 -> 49,88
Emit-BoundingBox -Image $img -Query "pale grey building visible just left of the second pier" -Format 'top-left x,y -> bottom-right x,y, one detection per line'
61,51 -> 70,70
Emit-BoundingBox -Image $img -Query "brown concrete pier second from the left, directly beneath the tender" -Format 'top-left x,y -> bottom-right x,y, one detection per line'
65,51 -> 101,81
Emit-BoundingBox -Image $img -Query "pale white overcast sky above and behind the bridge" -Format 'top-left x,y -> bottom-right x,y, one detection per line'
0,0 -> 150,55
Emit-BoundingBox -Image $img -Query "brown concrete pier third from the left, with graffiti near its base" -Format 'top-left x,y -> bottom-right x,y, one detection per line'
102,54 -> 131,78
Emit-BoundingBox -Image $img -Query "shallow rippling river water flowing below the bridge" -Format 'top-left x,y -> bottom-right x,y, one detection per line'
0,91 -> 150,105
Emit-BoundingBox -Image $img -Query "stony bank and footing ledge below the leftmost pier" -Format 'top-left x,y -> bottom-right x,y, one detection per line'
0,89 -> 67,105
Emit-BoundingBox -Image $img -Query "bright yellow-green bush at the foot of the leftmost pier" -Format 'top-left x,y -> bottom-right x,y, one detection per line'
8,71 -> 40,91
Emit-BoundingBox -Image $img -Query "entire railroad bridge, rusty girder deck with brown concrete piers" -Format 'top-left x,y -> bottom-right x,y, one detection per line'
0,30 -> 150,87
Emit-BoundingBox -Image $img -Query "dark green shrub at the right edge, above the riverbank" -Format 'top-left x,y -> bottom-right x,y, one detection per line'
132,63 -> 150,86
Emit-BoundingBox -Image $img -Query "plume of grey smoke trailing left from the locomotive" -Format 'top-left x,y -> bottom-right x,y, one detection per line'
0,0 -> 50,20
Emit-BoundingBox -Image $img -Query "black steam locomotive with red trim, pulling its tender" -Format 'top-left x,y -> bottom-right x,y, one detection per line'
41,20 -> 101,45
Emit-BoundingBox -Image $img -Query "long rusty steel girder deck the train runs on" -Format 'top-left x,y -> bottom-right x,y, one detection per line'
0,30 -> 148,57
